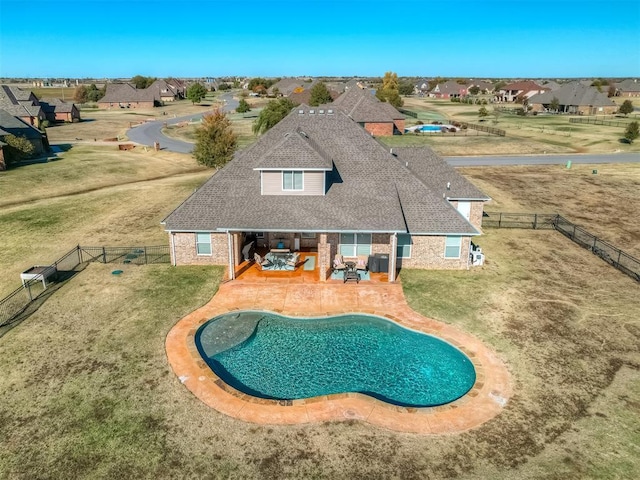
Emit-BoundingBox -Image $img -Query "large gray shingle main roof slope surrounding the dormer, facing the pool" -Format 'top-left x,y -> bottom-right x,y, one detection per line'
164,107 -> 479,235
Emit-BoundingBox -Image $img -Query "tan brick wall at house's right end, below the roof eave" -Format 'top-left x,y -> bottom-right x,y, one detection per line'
398,235 -> 471,270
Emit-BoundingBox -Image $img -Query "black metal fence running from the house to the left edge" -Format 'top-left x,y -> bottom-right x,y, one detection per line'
0,245 -> 171,327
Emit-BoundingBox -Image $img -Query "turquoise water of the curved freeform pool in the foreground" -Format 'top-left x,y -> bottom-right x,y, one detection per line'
195,311 -> 476,407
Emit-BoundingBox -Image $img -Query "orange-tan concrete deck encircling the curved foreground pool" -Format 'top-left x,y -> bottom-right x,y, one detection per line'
166,281 -> 512,434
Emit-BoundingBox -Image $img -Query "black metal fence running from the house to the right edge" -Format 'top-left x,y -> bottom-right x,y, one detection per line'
482,212 -> 640,282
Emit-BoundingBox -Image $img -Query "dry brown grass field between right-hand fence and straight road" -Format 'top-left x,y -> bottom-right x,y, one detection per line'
460,163 -> 640,257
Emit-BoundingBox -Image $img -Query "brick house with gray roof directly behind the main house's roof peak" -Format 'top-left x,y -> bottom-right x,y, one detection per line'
325,87 -> 405,136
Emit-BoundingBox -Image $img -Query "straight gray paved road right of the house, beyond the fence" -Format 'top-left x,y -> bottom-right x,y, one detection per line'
445,153 -> 640,167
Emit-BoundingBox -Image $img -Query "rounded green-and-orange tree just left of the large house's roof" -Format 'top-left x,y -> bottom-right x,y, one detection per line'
193,108 -> 238,170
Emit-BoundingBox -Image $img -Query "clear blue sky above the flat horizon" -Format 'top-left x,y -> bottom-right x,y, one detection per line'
0,0 -> 640,78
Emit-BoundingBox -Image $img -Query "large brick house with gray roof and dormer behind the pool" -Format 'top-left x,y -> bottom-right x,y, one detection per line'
162,105 -> 489,281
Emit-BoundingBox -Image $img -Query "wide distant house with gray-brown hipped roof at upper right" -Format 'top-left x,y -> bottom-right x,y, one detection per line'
529,82 -> 618,115
